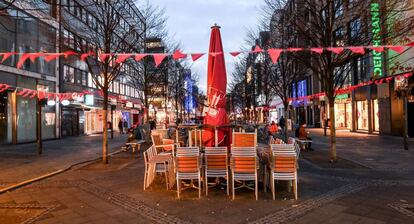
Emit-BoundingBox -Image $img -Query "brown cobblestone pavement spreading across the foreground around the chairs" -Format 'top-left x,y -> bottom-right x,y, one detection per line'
0,132 -> 414,223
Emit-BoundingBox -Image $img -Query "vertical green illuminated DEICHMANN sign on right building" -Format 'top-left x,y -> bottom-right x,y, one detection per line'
371,2 -> 383,77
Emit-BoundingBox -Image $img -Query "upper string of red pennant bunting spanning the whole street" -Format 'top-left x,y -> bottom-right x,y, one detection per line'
0,42 -> 414,69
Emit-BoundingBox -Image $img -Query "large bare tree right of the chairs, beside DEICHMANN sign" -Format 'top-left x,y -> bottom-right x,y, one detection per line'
264,0 -> 413,161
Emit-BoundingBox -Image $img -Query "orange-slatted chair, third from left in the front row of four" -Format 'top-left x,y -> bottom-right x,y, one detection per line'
231,147 -> 259,200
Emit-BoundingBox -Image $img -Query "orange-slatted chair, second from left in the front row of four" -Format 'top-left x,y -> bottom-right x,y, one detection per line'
204,147 -> 229,195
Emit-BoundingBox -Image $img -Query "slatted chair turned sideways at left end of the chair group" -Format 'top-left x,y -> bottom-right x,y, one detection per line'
144,146 -> 174,190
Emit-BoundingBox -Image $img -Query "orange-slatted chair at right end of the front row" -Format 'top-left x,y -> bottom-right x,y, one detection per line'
270,144 -> 298,200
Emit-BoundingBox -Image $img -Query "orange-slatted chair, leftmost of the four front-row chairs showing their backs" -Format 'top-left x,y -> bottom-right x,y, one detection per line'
175,147 -> 201,198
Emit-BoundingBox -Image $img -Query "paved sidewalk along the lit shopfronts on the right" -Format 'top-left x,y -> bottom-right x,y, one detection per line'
308,129 -> 414,171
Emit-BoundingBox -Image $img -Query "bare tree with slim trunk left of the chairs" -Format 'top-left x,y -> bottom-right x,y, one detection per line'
62,0 -> 147,163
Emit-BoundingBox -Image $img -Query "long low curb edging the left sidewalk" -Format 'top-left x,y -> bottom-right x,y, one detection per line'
0,149 -> 124,194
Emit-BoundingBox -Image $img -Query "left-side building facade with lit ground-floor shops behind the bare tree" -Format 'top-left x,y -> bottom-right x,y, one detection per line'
0,0 -> 145,144
